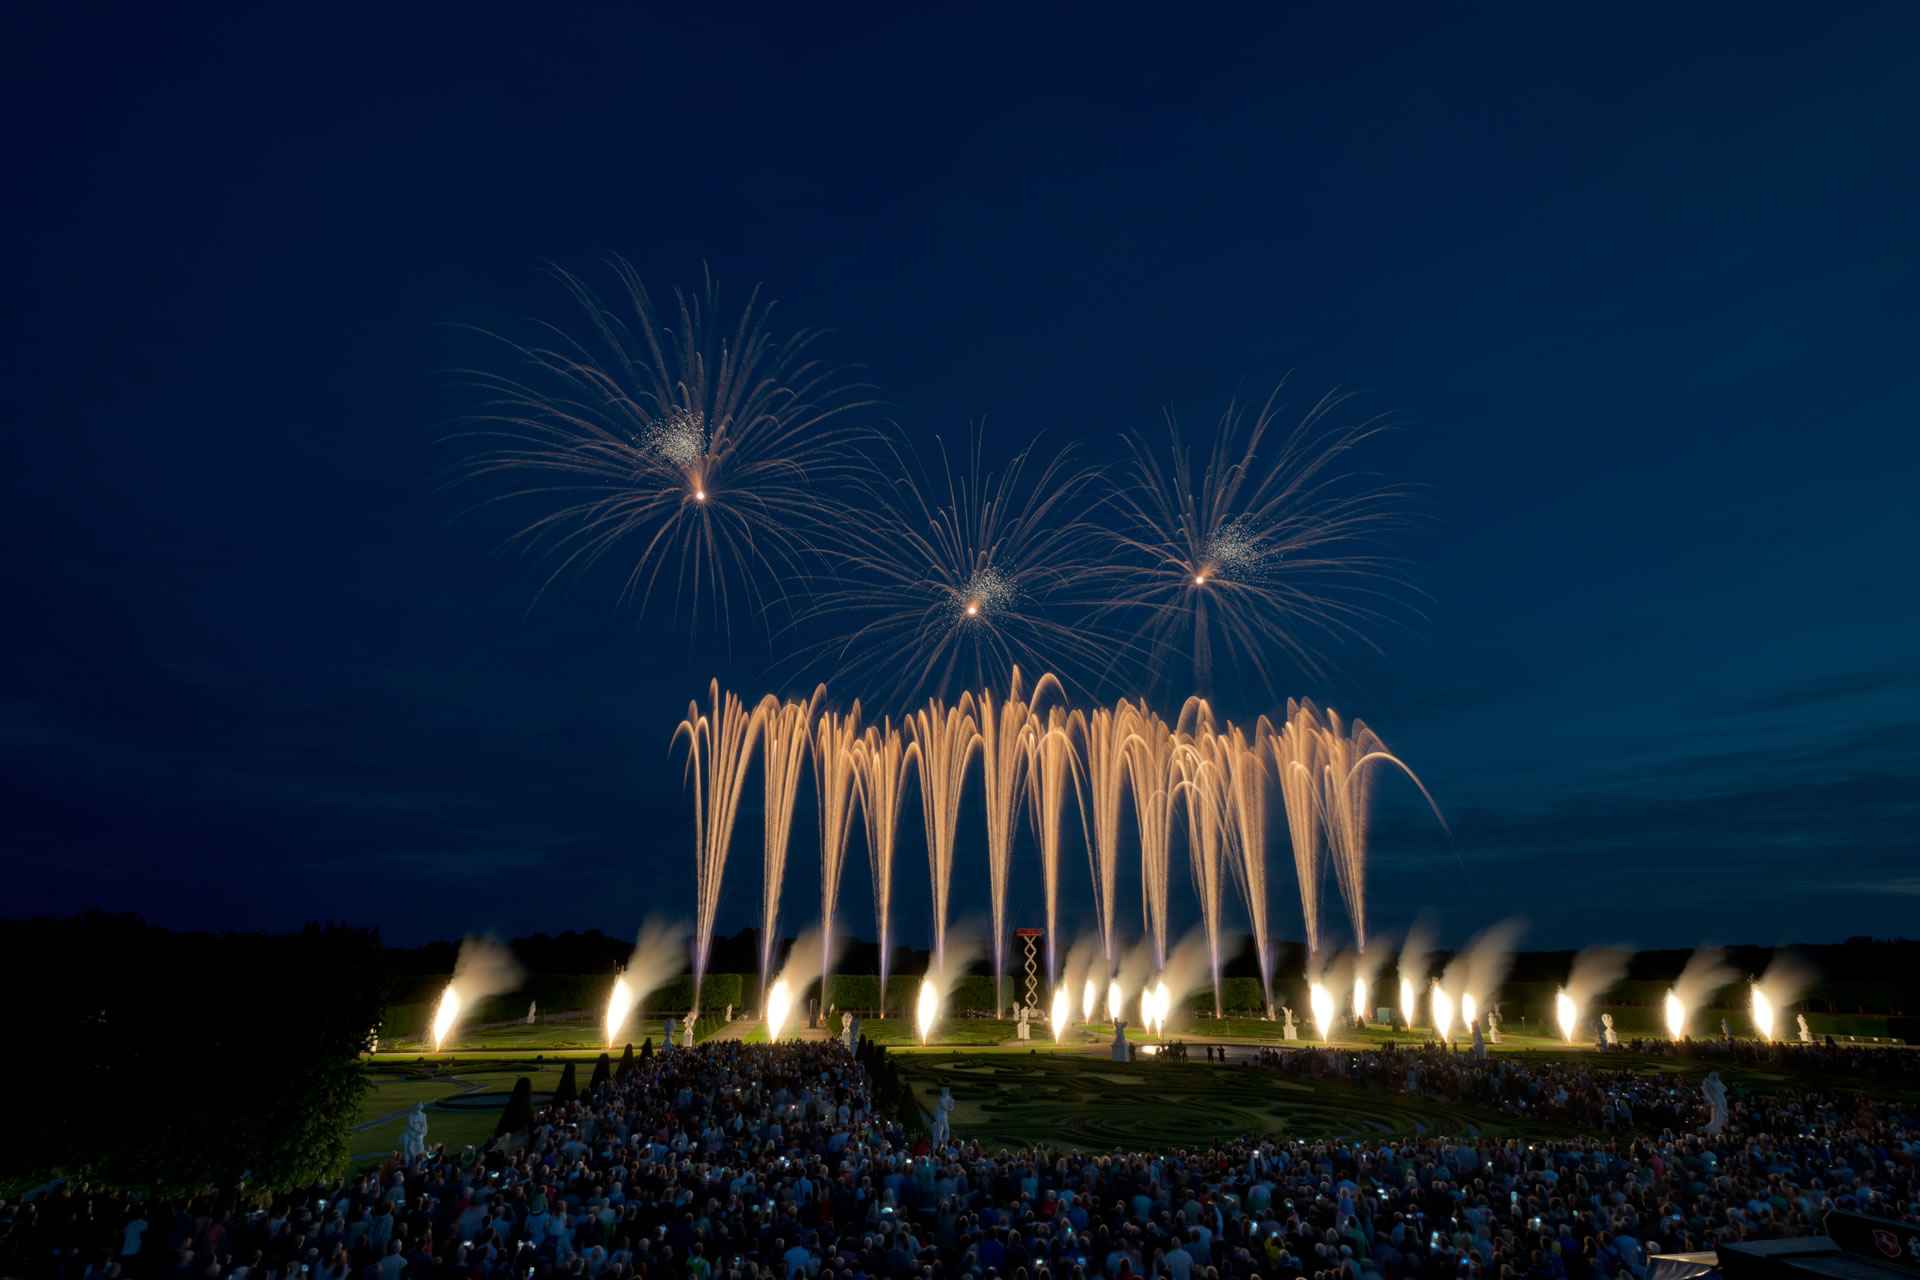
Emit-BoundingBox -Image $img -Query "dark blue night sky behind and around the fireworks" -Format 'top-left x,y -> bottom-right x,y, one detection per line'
0,2 -> 1920,946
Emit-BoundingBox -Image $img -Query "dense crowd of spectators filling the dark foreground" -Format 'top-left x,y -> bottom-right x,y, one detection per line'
0,1042 -> 1920,1280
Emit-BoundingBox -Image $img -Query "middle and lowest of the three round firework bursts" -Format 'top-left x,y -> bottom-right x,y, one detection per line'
791,438 -> 1112,699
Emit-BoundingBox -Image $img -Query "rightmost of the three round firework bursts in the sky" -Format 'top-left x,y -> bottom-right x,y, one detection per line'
1098,388 -> 1402,691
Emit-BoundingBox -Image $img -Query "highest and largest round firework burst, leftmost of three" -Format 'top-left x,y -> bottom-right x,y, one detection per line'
449,259 -> 872,633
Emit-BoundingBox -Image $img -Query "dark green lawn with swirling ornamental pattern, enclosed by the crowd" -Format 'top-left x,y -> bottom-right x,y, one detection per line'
897,1052 -> 1555,1150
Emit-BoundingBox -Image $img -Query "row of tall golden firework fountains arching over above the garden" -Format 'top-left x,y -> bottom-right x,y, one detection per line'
674,668 -> 1440,1021
